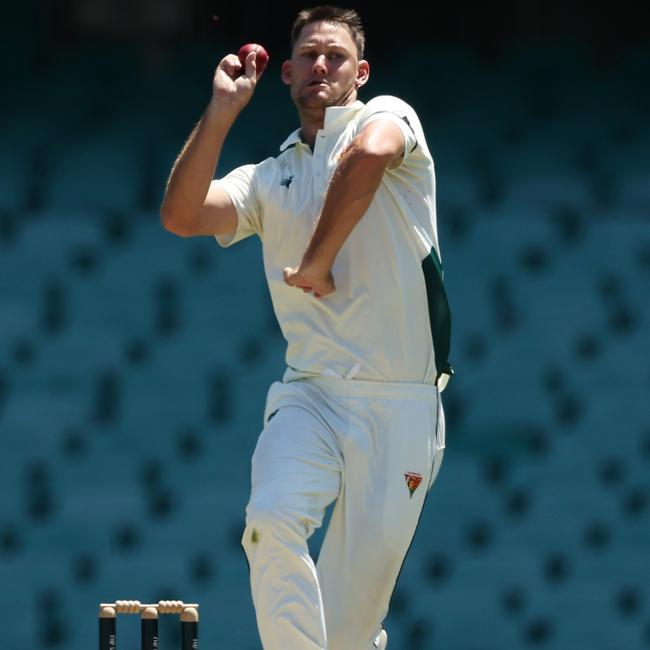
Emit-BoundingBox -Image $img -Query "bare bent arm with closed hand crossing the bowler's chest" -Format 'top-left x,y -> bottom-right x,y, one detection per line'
284,119 -> 404,298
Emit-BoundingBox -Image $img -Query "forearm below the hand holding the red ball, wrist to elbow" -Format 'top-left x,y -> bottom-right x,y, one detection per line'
161,102 -> 237,220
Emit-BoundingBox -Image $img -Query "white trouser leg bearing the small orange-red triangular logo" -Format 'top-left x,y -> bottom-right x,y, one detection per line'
318,392 -> 442,650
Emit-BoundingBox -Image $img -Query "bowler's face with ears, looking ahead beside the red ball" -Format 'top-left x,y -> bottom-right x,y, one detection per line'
282,22 -> 369,109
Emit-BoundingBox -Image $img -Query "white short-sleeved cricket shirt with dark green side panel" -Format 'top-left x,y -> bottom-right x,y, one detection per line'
216,96 -> 451,383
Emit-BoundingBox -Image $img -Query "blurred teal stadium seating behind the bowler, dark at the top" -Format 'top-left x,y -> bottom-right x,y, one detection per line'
0,0 -> 650,650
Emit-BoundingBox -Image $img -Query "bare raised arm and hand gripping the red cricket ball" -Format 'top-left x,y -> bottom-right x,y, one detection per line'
160,52 -> 256,237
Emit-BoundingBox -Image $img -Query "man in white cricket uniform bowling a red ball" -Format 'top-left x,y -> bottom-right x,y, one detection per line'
161,7 -> 452,650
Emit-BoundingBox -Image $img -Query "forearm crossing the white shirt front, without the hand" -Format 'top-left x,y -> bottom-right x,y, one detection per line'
303,147 -> 389,270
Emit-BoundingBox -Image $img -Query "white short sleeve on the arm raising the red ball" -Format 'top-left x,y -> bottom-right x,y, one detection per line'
214,165 -> 262,247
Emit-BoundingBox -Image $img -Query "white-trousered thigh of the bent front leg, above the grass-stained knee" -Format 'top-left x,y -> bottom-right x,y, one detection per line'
247,403 -> 341,536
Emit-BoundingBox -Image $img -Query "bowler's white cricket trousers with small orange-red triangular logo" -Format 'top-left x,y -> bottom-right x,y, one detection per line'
242,378 -> 445,650
